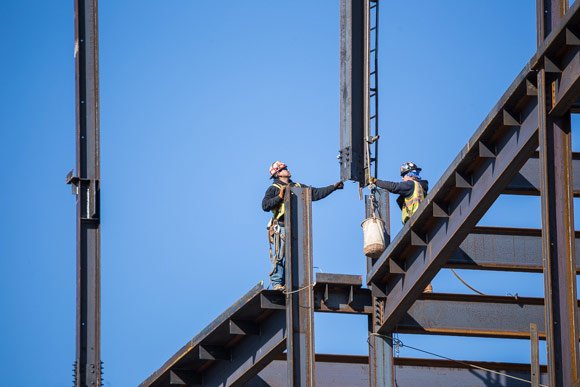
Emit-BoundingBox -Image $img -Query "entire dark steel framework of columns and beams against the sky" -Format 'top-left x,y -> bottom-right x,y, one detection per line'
67,0 -> 580,387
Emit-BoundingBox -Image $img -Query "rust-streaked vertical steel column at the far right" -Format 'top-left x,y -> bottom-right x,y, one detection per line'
537,0 -> 579,386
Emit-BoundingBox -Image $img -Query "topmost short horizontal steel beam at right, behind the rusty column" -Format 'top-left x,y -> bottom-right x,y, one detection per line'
503,152 -> 580,197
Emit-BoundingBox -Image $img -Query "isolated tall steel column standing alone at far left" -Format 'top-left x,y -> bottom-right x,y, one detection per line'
67,0 -> 101,387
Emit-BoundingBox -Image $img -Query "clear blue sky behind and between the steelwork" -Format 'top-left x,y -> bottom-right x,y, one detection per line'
0,0 -> 579,387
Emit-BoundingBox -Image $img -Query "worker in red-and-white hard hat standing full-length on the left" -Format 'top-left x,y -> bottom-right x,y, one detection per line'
262,161 -> 344,291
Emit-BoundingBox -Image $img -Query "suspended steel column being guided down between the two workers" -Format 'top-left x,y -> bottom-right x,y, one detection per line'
338,0 -> 366,184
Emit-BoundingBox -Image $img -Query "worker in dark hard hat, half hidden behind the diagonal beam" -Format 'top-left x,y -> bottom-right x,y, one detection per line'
371,161 -> 433,293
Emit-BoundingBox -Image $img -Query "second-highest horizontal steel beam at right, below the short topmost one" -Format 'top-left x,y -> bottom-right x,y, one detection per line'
444,227 -> 580,273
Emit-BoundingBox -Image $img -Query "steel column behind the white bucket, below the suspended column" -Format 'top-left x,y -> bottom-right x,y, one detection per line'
365,189 -> 395,387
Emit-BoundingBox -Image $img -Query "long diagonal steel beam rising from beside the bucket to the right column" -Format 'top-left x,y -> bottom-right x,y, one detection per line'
368,59 -> 538,332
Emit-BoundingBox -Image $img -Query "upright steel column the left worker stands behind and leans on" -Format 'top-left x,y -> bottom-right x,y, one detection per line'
284,187 -> 316,386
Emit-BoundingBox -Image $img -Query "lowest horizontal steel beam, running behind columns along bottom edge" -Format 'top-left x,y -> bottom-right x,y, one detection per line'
246,355 -> 547,387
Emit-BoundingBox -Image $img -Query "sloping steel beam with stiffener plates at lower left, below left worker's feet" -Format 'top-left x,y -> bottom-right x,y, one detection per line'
140,284 -> 286,387
